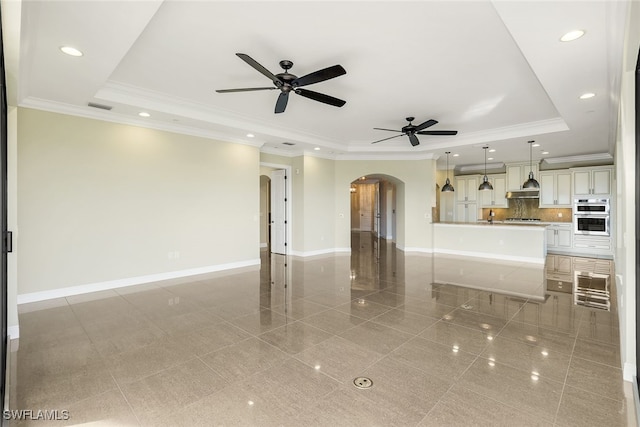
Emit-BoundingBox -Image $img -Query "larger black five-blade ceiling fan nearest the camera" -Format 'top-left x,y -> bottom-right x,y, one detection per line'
216,53 -> 347,113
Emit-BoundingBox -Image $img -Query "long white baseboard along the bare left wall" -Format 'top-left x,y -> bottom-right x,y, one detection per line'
17,258 -> 260,305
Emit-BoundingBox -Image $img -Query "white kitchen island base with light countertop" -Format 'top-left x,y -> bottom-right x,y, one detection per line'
433,222 -> 547,265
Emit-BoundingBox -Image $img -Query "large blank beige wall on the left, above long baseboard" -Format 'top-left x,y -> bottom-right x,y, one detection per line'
18,109 -> 260,295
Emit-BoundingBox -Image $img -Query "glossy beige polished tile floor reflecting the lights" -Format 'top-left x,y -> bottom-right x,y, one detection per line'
11,233 -> 636,426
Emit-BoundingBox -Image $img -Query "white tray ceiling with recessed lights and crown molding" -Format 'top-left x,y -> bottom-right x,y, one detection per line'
3,0 -> 627,171
